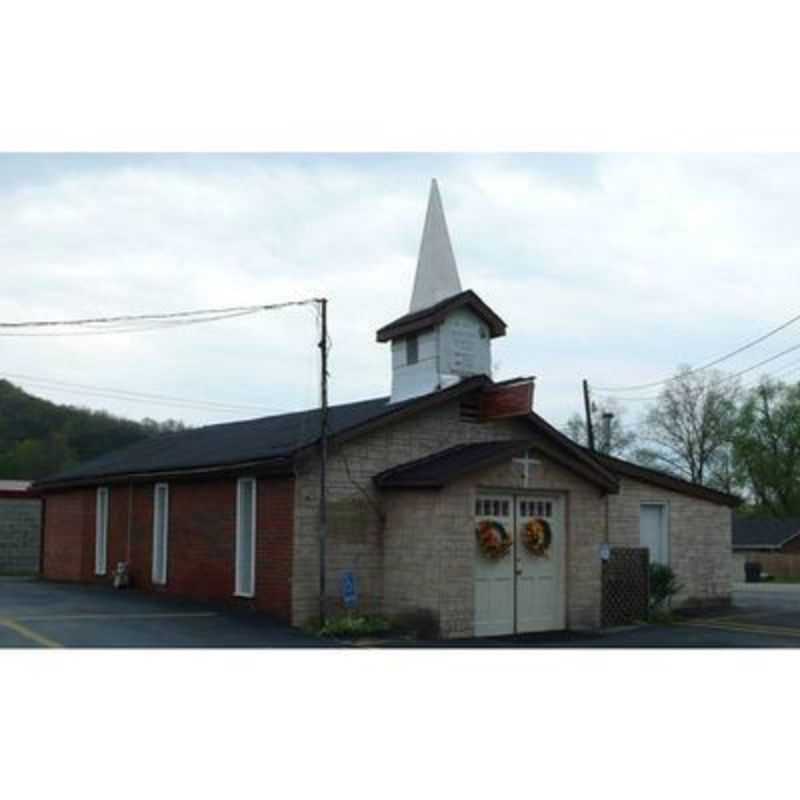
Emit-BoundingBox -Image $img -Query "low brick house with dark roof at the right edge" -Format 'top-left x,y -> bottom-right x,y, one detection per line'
733,516 -> 800,580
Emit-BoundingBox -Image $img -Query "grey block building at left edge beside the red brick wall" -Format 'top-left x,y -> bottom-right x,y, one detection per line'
0,480 -> 42,575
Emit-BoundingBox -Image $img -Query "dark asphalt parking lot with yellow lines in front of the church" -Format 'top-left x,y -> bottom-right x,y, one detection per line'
0,578 -> 800,648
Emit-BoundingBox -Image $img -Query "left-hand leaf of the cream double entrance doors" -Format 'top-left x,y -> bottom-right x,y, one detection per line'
474,494 -> 514,636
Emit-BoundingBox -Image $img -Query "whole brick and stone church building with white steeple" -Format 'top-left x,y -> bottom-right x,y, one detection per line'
38,183 -> 738,637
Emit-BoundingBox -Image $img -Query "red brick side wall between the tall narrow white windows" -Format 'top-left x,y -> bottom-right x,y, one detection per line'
43,478 -> 294,620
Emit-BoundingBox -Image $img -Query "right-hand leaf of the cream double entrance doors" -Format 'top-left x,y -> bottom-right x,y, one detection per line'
515,495 -> 566,633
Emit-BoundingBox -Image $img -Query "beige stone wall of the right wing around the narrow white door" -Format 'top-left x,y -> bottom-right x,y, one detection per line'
609,478 -> 733,605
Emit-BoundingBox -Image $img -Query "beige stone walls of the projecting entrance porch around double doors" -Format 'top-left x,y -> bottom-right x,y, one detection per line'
384,458 -> 605,637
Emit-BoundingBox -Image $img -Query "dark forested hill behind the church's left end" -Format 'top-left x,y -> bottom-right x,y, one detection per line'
0,380 -> 184,480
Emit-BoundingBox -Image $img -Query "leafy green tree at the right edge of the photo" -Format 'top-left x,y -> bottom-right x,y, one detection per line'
733,380 -> 800,517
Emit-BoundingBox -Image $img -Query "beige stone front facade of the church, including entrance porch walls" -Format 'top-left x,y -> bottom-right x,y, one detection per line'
293,400 -> 605,636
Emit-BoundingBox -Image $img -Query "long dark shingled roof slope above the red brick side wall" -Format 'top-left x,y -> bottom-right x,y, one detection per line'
35,375 -> 491,490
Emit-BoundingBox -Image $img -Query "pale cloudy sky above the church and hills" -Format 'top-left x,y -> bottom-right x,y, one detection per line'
0,153 -> 800,426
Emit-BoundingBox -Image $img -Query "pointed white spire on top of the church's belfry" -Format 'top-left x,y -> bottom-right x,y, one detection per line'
409,178 -> 461,311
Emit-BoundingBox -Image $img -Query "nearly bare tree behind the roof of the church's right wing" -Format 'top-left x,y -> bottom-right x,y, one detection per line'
638,367 -> 741,491
